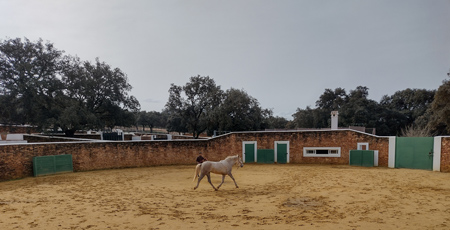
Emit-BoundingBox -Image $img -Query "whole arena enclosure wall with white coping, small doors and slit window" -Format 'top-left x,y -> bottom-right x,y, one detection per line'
0,129 -> 450,181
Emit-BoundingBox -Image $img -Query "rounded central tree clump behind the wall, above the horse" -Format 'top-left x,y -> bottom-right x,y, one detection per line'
165,75 -> 276,138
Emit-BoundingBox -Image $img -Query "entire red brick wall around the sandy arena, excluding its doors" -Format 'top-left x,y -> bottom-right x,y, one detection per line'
0,130 -> 440,181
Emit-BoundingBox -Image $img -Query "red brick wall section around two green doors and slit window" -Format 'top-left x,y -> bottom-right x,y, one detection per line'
208,130 -> 389,167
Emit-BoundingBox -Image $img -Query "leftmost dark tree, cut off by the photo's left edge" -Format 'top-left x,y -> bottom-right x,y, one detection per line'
0,38 -> 63,127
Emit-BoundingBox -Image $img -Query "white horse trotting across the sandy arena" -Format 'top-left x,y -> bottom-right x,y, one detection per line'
193,155 -> 244,191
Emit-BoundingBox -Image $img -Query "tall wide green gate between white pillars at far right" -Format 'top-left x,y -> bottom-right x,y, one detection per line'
395,137 -> 434,170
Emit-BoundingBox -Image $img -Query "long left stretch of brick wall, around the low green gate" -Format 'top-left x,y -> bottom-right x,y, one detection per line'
0,141 -> 213,181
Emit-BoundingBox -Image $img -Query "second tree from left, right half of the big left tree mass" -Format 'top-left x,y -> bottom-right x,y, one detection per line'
58,57 -> 139,133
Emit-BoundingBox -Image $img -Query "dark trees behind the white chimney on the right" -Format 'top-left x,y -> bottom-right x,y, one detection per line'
290,86 -> 435,135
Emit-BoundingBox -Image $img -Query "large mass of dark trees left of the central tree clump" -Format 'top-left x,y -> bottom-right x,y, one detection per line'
0,38 -> 139,135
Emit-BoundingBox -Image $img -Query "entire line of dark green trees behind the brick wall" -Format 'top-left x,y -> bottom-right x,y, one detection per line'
0,38 -> 450,138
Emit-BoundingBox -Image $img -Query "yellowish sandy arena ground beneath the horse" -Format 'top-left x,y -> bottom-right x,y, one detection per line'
0,164 -> 450,230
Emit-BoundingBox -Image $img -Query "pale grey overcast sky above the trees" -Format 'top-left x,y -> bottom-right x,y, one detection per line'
0,0 -> 450,119
